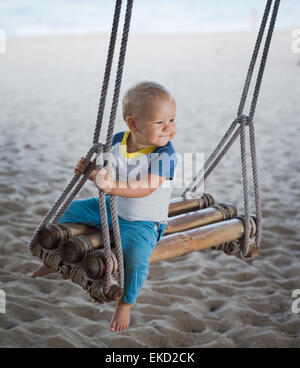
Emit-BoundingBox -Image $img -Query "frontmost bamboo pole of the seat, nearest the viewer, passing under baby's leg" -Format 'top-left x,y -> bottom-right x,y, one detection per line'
82,218 -> 256,278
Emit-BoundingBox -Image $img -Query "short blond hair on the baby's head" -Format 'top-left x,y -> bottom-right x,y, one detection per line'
122,81 -> 174,120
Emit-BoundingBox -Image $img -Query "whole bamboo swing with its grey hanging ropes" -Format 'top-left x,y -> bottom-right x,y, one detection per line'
29,0 -> 280,303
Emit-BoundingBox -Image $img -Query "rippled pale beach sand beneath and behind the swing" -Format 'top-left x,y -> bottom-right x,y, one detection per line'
0,30 -> 300,348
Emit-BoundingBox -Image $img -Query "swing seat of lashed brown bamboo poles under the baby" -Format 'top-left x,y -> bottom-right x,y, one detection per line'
33,193 -> 257,303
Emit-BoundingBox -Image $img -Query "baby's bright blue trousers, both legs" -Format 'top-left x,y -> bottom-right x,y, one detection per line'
59,195 -> 167,304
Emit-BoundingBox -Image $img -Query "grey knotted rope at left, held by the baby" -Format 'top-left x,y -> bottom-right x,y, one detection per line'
28,0 -> 133,300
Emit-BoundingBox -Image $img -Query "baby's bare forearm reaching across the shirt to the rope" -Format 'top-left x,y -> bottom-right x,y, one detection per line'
94,169 -> 166,198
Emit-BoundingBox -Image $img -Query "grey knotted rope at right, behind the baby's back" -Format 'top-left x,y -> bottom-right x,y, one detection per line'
182,0 -> 280,255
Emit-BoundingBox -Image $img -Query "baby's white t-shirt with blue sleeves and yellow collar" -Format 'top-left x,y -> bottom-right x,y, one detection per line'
107,131 -> 177,222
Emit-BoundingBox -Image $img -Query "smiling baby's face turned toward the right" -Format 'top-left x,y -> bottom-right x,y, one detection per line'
136,98 -> 176,147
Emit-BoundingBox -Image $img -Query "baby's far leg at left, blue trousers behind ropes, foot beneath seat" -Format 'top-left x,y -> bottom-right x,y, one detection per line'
30,196 -> 111,278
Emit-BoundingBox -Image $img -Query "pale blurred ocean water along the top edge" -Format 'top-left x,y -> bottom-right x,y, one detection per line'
0,0 -> 300,37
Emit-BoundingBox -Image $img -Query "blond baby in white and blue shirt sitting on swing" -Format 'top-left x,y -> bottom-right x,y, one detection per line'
32,82 -> 177,332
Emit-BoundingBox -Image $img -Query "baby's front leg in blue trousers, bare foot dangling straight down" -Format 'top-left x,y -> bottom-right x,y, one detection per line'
110,219 -> 157,331
